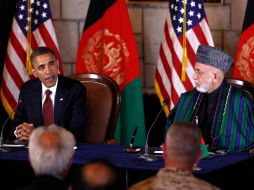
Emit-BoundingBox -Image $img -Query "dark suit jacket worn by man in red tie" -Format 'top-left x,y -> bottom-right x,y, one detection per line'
13,75 -> 86,142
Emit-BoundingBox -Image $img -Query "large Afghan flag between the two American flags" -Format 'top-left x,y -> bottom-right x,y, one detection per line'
76,0 -> 146,145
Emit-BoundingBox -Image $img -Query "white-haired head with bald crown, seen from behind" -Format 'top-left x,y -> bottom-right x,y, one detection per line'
28,125 -> 75,179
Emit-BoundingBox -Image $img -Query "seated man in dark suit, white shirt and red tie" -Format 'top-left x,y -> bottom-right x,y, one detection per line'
14,47 -> 86,142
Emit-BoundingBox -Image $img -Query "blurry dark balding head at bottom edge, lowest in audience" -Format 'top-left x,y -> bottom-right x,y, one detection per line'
72,159 -> 118,190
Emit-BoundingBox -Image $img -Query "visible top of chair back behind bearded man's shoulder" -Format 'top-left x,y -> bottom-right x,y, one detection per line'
227,78 -> 254,101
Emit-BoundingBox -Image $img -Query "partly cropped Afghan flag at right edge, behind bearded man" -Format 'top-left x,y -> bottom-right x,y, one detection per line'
234,0 -> 254,83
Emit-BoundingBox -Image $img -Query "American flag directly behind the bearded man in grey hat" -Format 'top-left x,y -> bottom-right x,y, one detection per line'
155,0 -> 214,115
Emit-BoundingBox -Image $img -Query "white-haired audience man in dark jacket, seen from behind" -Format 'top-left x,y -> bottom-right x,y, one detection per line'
19,125 -> 75,190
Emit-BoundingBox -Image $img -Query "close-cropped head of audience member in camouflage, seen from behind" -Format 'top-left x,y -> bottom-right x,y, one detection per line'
163,122 -> 202,170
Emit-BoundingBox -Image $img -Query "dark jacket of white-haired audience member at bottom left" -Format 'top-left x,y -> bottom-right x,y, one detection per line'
18,175 -> 67,190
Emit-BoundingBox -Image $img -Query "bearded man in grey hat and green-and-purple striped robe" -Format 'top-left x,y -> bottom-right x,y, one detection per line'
166,45 -> 254,151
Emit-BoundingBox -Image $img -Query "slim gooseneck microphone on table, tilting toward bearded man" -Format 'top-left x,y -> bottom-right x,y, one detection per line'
139,99 -> 169,162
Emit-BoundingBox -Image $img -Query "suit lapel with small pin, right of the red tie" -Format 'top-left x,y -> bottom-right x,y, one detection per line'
54,75 -> 67,124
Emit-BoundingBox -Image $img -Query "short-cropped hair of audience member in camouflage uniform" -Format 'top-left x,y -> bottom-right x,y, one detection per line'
166,122 -> 201,162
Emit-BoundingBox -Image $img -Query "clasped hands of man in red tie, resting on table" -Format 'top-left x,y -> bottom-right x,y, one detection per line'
16,123 -> 34,141
